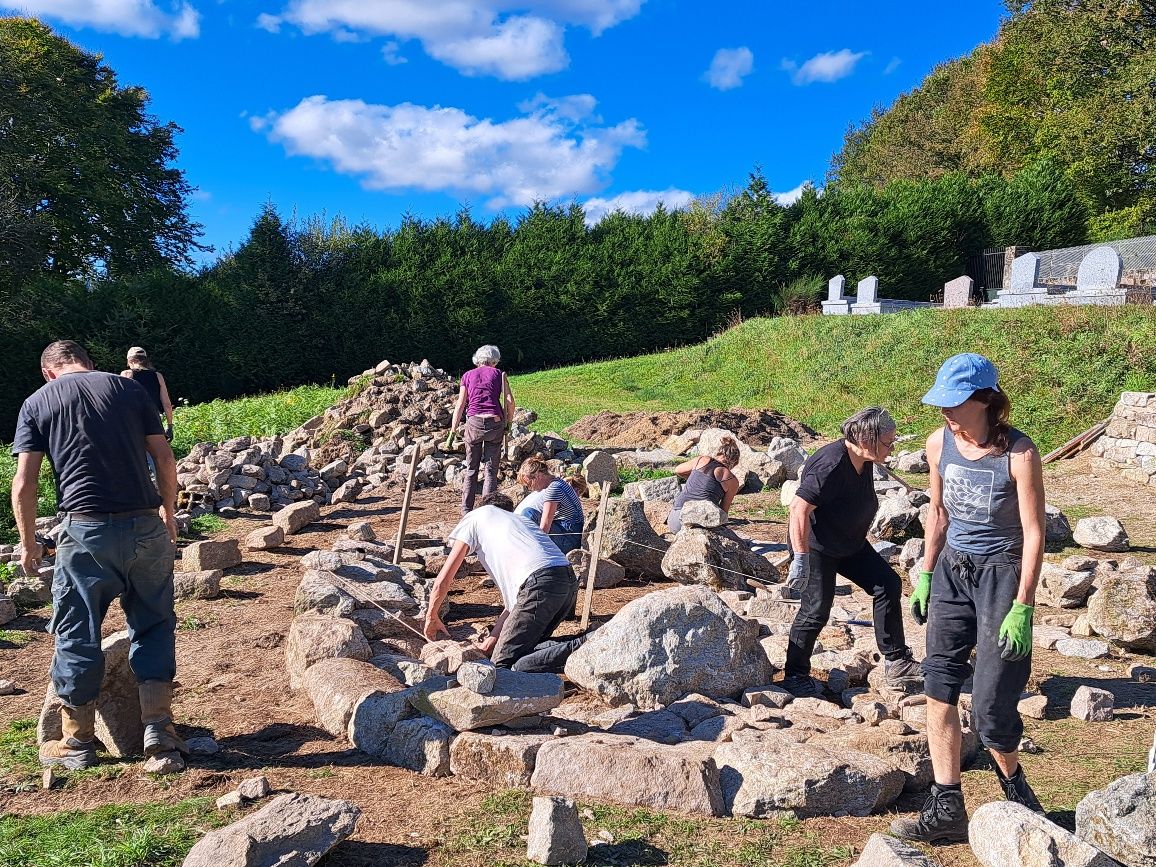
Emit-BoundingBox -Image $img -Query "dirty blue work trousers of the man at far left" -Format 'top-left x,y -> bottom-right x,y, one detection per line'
50,514 -> 177,707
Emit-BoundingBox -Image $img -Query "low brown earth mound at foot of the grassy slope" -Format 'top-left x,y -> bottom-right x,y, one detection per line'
566,407 -> 818,449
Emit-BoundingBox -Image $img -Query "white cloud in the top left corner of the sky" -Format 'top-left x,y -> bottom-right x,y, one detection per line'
0,0 -> 201,39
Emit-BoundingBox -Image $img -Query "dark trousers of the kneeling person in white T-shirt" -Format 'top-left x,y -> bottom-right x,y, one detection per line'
492,566 -> 580,672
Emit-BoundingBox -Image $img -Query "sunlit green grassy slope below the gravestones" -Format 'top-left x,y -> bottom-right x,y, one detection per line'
512,307 -> 1156,451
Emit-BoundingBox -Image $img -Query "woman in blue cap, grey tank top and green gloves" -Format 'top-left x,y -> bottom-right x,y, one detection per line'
891,353 -> 1044,843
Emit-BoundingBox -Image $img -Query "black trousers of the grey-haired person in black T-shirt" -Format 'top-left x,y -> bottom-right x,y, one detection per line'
786,541 -> 907,677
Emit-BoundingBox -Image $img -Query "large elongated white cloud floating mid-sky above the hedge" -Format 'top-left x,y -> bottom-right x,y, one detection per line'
250,96 -> 646,208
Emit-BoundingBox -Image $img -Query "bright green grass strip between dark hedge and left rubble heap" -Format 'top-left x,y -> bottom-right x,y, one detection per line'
172,385 -> 347,457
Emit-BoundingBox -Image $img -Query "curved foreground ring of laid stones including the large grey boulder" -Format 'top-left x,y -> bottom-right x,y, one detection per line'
286,585 -> 978,817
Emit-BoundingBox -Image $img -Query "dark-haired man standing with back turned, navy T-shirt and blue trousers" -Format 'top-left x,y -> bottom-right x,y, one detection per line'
12,340 -> 185,770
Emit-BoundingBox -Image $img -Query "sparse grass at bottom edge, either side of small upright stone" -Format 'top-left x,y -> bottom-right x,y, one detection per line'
439,791 -> 852,867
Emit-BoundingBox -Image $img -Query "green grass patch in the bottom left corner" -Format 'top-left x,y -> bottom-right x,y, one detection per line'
0,798 -> 220,867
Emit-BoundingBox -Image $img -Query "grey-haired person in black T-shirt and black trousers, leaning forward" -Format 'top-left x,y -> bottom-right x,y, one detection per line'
780,407 -> 922,698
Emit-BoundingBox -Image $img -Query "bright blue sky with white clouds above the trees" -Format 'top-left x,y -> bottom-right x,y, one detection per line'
0,0 -> 1005,261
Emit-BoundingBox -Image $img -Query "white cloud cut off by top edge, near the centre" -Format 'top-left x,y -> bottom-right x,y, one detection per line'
258,0 -> 644,81
